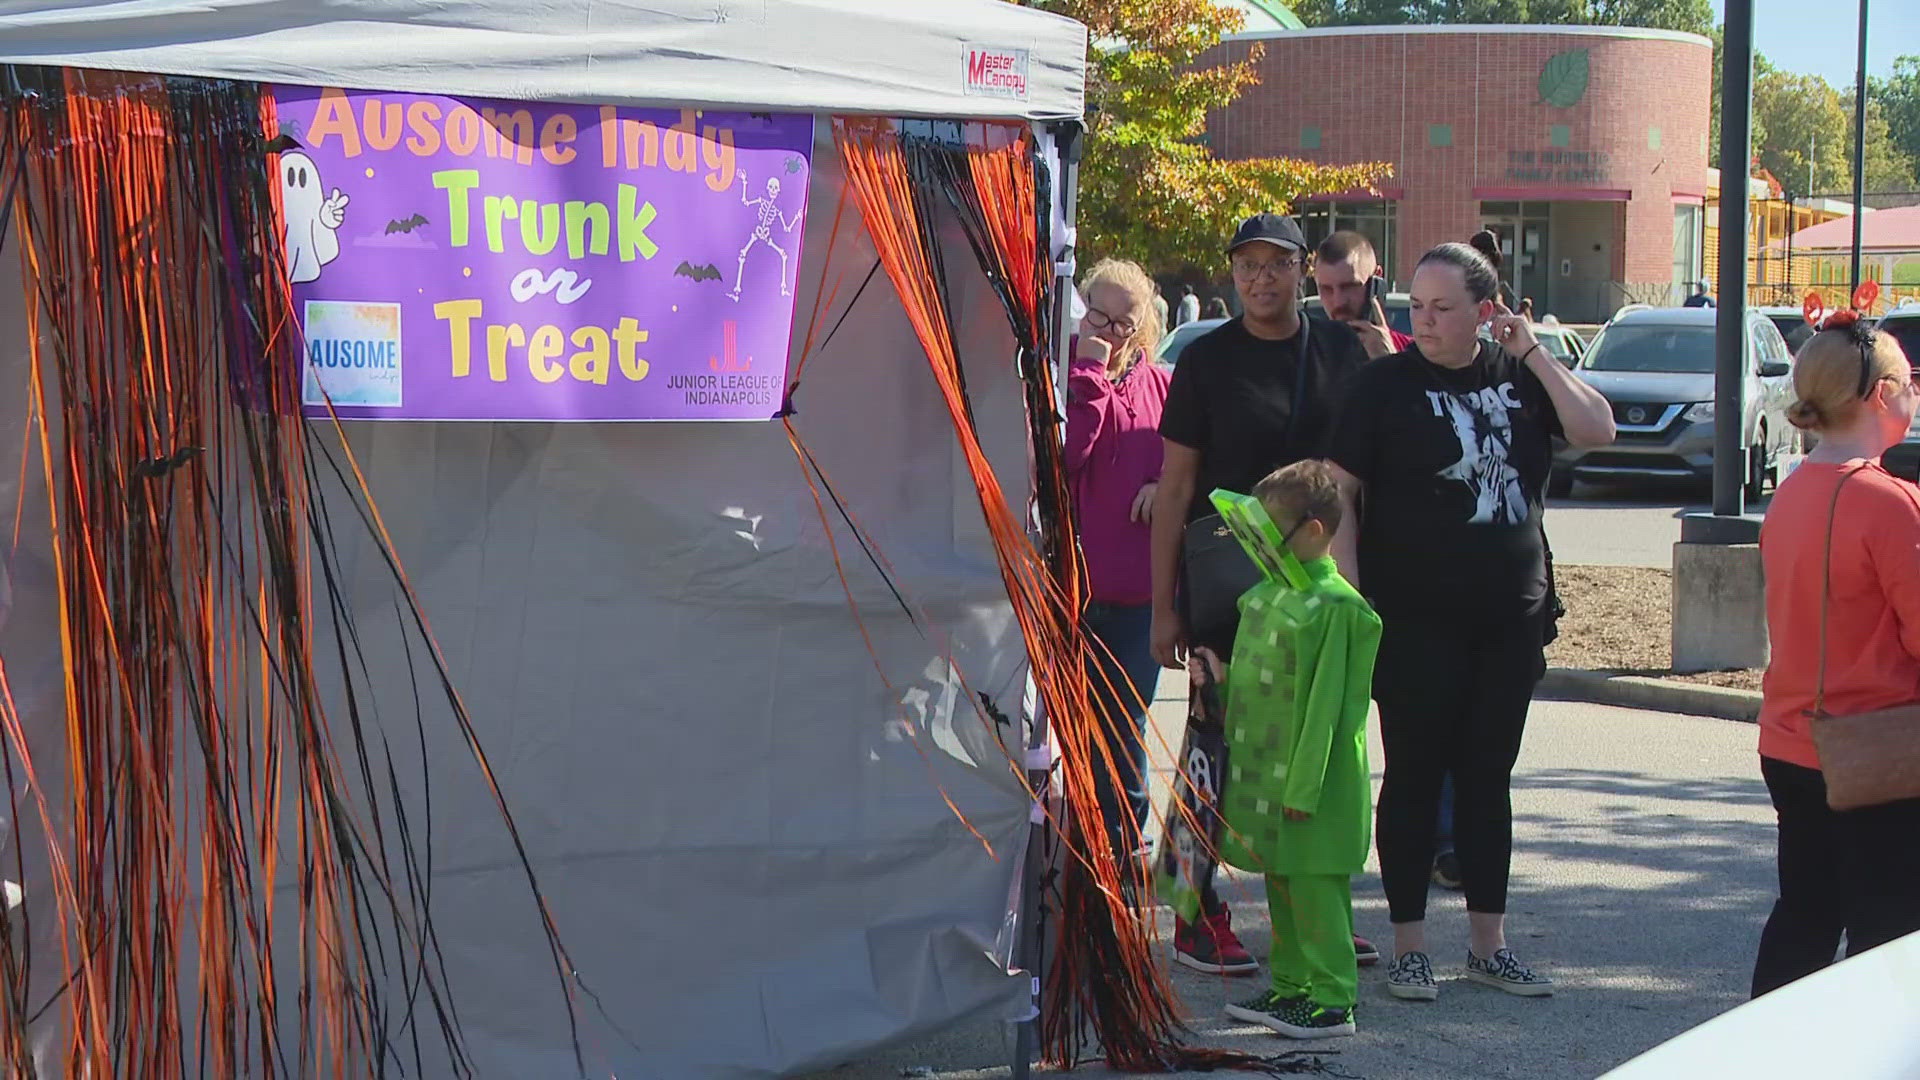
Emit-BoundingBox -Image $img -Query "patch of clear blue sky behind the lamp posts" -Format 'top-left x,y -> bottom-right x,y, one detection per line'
1713,0 -> 1920,86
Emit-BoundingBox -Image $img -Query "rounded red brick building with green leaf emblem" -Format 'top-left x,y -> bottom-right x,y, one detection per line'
1208,27 -> 1713,321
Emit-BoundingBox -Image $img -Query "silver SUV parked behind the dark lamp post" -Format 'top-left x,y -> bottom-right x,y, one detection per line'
1548,307 -> 1799,500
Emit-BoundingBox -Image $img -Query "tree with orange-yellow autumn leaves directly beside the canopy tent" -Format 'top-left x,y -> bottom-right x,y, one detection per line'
1014,0 -> 1390,273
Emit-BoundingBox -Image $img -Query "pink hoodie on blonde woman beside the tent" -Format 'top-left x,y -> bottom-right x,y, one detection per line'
1066,350 -> 1171,605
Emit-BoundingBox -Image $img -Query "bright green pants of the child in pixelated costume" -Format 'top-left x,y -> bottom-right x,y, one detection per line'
1267,874 -> 1359,1009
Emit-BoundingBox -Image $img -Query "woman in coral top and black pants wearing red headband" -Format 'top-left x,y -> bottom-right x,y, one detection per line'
1753,311 -> 1920,997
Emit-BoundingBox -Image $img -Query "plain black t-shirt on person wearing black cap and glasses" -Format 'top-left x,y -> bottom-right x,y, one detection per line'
1160,317 -> 1367,521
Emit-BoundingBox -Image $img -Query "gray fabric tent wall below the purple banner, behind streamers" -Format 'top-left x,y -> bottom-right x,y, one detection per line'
0,107 -> 1082,1080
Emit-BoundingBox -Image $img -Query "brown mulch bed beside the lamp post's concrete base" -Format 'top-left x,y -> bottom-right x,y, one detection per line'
1548,565 -> 1761,690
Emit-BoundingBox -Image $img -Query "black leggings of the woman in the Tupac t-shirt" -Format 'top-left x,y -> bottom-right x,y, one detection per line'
1373,617 -> 1546,922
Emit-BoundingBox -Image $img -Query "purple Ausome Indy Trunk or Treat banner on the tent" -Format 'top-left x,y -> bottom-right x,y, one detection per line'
275,86 -> 814,421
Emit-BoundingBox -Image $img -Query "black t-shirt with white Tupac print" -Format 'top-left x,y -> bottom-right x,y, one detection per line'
1331,342 -> 1563,621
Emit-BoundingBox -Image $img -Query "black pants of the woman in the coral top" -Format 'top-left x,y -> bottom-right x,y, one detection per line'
1753,757 -> 1920,997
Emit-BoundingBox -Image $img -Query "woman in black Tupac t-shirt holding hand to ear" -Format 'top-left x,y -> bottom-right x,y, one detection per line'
1331,244 -> 1613,1001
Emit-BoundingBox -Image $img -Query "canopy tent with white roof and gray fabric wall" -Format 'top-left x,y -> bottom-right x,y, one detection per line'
0,0 -> 1087,1080
